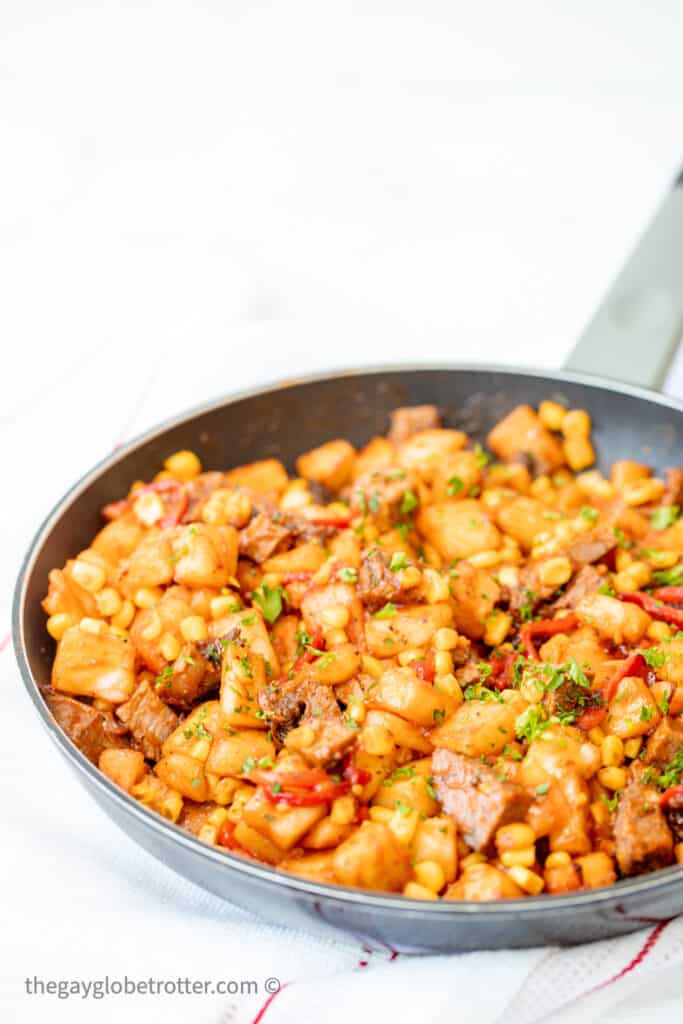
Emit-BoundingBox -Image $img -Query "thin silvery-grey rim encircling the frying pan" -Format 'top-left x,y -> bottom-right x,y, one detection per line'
11,362 -> 683,921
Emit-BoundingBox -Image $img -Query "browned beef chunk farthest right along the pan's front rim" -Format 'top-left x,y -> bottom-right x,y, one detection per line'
614,766 -> 674,874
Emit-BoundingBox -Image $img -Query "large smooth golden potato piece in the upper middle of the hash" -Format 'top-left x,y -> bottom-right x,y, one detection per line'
417,498 -> 502,560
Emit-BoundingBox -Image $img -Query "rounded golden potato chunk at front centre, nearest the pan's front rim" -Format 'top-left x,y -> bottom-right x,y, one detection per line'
332,821 -> 411,892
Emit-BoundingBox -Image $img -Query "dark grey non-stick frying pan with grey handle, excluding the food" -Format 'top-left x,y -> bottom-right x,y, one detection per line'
13,172 -> 683,952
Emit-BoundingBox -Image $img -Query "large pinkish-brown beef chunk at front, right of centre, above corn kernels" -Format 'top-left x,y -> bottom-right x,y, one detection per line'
432,749 -> 531,850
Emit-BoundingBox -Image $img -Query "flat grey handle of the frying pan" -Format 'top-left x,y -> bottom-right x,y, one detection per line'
565,171 -> 683,390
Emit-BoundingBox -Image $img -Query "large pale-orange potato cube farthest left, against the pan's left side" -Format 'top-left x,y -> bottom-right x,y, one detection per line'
52,626 -> 135,703
